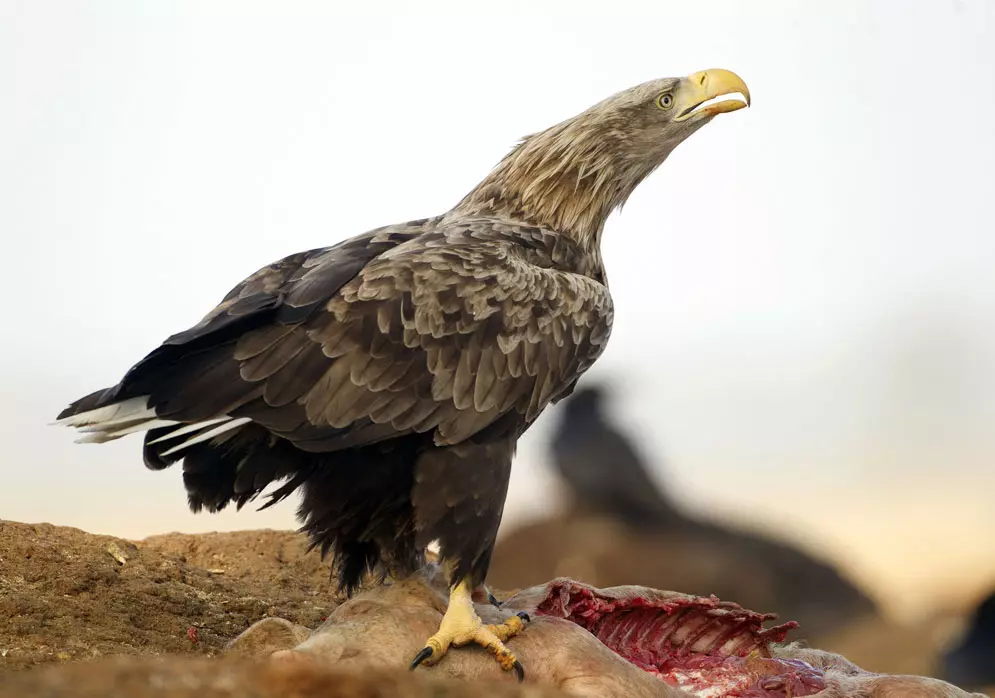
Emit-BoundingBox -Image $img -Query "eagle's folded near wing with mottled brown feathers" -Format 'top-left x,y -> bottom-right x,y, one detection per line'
144,221 -> 612,451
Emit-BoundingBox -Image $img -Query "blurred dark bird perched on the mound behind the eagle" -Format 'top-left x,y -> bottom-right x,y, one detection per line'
552,386 -> 681,528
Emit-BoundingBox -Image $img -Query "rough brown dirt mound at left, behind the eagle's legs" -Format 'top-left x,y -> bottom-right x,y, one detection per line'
0,521 -> 337,669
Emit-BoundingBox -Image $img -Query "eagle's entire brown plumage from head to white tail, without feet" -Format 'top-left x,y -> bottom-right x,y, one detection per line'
60,71 -> 745,608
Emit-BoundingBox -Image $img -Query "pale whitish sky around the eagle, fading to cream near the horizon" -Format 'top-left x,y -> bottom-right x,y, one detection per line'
0,0 -> 995,612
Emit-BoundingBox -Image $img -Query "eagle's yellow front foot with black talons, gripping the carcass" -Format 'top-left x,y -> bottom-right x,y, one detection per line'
411,581 -> 529,681
